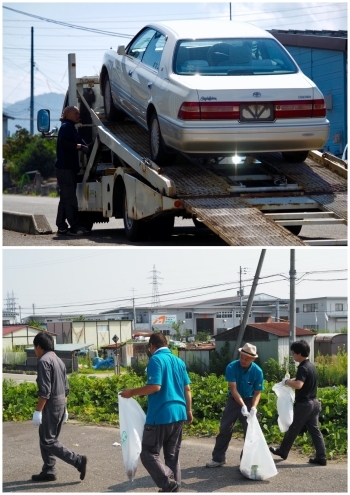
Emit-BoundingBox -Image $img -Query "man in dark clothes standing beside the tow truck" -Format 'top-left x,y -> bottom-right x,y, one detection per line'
55,106 -> 89,235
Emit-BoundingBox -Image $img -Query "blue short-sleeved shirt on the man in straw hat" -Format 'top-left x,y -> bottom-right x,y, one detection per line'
225,359 -> 264,399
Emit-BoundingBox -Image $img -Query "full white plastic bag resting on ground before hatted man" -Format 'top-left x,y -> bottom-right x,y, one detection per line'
239,414 -> 277,480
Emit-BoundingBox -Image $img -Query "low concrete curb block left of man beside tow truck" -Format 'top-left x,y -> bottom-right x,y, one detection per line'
2,211 -> 52,235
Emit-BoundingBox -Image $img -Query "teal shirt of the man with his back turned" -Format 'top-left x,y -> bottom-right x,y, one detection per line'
146,347 -> 191,425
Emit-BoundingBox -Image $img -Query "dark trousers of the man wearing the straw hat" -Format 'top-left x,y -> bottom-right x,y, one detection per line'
212,396 -> 252,462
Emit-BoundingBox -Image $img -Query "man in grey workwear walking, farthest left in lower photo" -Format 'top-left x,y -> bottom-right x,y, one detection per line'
32,332 -> 87,482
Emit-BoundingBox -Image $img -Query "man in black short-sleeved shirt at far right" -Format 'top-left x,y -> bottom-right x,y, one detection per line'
270,340 -> 327,466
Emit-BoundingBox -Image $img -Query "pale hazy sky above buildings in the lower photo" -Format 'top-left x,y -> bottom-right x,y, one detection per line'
2,247 -> 348,318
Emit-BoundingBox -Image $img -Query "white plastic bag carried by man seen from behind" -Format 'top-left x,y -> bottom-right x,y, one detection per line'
118,394 -> 146,481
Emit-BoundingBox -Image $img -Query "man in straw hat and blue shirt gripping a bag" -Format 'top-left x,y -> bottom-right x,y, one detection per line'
206,343 -> 264,467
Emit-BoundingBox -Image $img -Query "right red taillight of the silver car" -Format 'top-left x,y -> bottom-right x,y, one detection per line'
275,100 -> 326,119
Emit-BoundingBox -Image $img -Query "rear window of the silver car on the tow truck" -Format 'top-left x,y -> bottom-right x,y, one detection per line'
173,38 -> 298,76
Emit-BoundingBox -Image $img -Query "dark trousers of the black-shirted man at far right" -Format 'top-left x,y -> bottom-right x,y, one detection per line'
280,399 -> 326,459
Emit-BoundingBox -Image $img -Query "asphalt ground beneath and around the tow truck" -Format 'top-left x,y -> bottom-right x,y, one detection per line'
3,194 -> 347,247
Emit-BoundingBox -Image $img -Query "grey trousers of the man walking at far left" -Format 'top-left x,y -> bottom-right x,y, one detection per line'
39,403 -> 82,474
